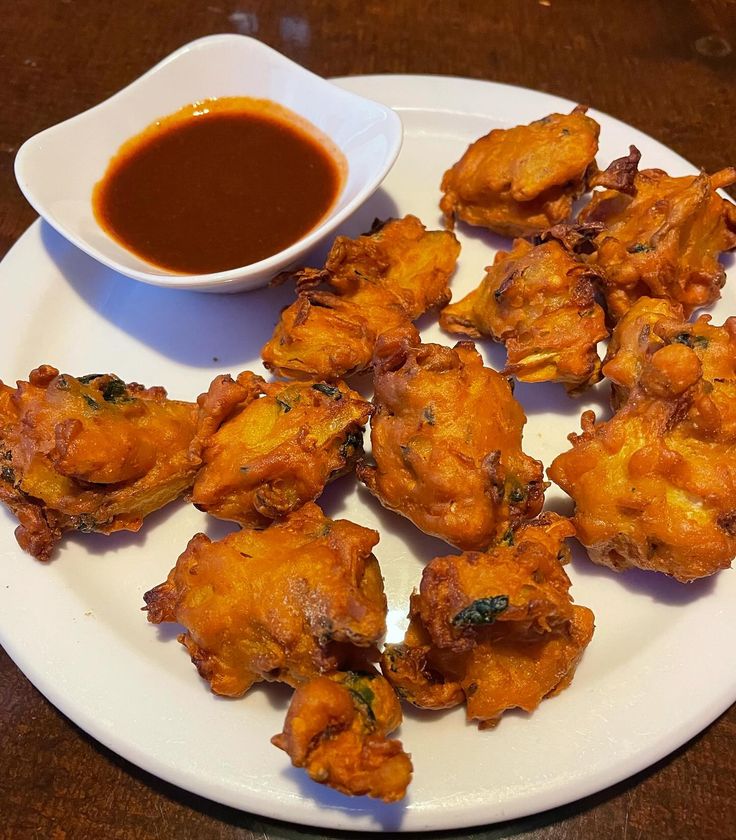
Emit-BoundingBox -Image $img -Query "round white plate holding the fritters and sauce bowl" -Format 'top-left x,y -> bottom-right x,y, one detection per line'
0,76 -> 736,831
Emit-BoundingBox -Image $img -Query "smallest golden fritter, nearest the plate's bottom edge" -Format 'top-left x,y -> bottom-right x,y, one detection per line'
271,671 -> 412,802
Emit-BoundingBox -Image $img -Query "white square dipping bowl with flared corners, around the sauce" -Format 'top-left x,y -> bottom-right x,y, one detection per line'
15,35 -> 402,292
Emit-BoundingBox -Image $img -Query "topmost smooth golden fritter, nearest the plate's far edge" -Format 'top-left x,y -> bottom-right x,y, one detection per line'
440,105 -> 600,236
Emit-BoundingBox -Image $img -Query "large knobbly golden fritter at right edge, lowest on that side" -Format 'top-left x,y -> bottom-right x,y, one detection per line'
548,338 -> 736,581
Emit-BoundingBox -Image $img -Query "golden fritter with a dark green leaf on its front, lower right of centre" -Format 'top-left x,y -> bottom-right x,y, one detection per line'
381,513 -> 594,729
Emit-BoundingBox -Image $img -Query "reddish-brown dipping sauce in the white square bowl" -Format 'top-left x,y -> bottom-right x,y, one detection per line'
92,96 -> 347,274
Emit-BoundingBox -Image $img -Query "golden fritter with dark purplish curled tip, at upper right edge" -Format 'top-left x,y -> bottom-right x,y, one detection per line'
579,146 -> 736,320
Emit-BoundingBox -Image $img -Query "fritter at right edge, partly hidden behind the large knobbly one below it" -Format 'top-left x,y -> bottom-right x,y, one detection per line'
603,297 -> 736,409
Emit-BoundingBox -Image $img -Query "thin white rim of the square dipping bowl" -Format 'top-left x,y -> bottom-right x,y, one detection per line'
14,33 -> 403,291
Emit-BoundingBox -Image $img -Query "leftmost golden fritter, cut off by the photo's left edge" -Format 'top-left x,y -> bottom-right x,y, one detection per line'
0,365 -> 197,560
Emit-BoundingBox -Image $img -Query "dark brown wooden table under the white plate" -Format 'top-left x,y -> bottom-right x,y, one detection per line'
0,0 -> 736,840
